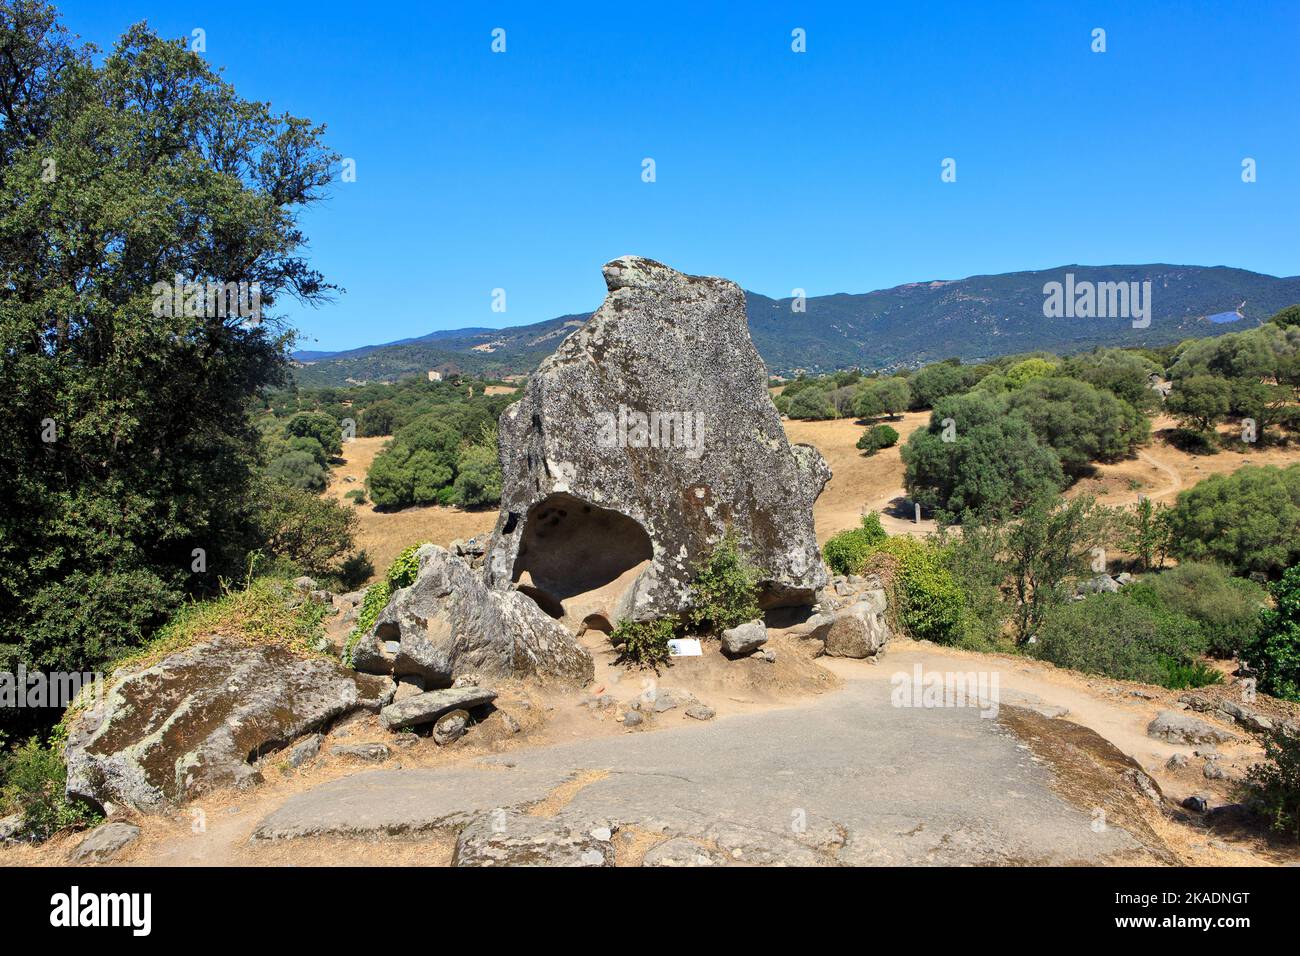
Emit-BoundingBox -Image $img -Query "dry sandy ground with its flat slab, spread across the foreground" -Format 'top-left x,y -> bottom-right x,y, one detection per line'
12,631 -> 1300,866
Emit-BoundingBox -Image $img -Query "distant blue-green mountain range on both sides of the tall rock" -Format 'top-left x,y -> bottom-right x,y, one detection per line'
293,264 -> 1300,388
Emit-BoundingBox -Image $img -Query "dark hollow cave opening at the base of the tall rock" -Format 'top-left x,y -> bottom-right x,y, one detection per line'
512,493 -> 654,630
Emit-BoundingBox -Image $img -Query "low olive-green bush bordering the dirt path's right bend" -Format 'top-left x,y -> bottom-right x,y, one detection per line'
1030,593 -> 1204,684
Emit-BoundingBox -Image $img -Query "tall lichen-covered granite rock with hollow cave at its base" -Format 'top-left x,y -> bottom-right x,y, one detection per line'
485,256 -> 831,627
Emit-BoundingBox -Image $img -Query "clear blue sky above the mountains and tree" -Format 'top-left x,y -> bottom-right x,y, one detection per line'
59,0 -> 1300,349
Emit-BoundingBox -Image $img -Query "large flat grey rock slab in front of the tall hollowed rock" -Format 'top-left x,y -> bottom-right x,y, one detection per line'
255,682 -> 1162,866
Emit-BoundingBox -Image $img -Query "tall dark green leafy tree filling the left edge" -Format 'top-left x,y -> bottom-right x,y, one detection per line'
0,0 -> 356,738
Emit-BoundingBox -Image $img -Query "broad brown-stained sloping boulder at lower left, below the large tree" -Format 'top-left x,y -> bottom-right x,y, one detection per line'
64,637 -> 394,810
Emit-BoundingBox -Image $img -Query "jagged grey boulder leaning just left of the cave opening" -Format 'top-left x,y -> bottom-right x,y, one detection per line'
352,545 -> 594,687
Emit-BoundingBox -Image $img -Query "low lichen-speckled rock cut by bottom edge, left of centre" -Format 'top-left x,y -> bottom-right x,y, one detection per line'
451,810 -> 614,866
